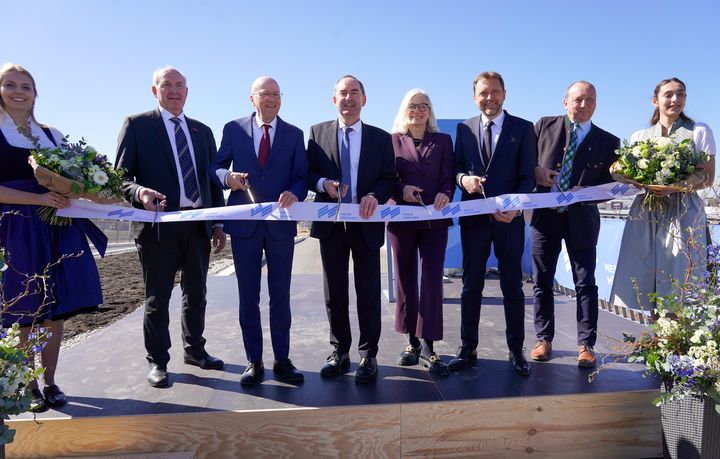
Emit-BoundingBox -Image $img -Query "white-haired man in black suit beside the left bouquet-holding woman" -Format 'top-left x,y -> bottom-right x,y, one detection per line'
115,67 -> 225,387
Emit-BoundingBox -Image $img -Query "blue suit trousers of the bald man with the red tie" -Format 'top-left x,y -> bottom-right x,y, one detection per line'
231,225 -> 295,362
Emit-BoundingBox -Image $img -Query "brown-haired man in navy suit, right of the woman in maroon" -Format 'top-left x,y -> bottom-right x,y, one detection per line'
449,72 -> 537,375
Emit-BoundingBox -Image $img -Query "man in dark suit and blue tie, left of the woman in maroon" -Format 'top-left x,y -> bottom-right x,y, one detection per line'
308,75 -> 397,383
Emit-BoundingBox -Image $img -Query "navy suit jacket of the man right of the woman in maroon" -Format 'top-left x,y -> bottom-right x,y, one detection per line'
455,112 -> 537,237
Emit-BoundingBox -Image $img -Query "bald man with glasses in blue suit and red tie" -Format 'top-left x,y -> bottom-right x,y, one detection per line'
210,77 -> 307,386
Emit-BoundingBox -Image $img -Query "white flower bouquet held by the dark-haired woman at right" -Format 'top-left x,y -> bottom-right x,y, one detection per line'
610,137 -> 709,210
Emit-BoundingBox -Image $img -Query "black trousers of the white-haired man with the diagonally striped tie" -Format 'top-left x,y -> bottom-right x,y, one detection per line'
135,222 -> 210,367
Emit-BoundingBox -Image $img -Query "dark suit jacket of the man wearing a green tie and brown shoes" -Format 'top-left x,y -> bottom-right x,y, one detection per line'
530,115 -> 620,248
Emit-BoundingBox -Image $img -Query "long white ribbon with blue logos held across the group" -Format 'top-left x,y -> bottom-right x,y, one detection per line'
57,182 -> 643,223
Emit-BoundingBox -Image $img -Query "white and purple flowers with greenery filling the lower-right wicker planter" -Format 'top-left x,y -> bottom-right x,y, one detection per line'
623,245 -> 720,413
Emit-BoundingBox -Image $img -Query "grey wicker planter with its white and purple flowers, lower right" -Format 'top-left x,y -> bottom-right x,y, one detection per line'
623,245 -> 720,458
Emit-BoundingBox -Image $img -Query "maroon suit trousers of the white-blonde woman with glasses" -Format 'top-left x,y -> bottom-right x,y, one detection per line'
388,224 -> 448,341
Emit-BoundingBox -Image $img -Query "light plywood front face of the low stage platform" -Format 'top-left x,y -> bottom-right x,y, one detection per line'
8,391 -> 662,458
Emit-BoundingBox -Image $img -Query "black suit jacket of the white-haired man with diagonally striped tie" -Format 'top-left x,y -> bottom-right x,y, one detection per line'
115,109 -> 225,241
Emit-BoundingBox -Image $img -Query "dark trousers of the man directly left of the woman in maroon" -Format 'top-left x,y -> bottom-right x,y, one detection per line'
320,223 -> 381,358
